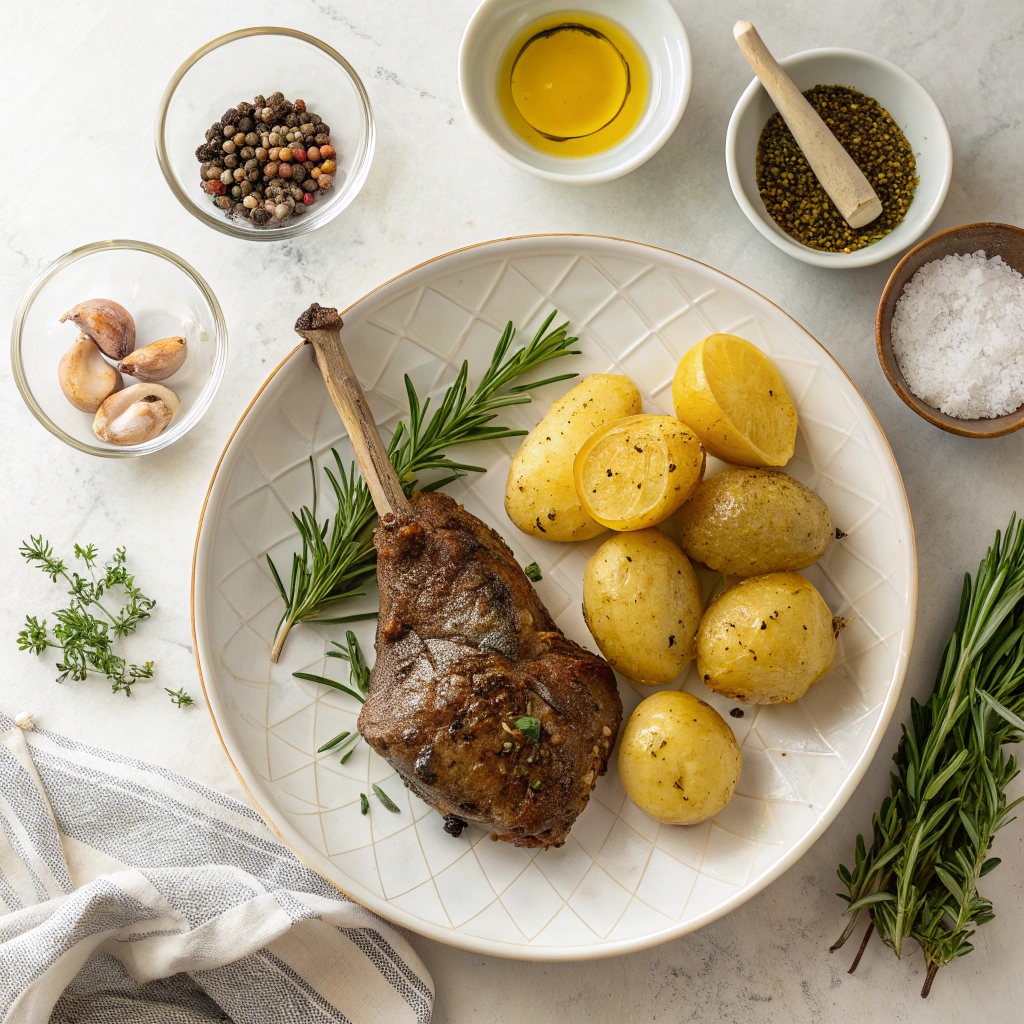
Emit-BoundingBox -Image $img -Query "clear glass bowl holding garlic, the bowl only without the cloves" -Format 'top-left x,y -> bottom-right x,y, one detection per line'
10,240 -> 227,459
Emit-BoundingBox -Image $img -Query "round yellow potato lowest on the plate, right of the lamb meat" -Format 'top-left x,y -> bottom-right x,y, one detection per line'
618,690 -> 743,825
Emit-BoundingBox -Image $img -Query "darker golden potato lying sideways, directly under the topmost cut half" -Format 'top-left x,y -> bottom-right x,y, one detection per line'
675,469 -> 836,577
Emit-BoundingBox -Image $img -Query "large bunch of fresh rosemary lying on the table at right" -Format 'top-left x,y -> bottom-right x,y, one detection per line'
833,519 -> 1024,996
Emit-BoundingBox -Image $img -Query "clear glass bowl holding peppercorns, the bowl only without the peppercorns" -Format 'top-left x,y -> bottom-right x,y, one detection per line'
157,28 -> 376,242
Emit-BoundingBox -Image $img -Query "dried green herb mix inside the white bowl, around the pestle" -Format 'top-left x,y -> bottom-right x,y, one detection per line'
757,85 -> 918,253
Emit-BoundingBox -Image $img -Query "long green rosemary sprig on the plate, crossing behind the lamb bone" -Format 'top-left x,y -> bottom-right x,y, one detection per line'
267,312 -> 579,662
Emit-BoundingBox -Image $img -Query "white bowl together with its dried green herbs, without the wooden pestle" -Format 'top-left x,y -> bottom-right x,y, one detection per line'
726,49 -> 952,268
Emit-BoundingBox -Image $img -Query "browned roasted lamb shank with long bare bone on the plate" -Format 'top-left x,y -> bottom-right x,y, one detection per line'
295,303 -> 623,847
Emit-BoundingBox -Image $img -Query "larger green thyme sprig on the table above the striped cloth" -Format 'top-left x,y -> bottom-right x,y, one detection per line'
17,537 -> 158,700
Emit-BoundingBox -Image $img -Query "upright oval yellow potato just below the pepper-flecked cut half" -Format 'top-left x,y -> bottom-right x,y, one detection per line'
583,529 -> 703,686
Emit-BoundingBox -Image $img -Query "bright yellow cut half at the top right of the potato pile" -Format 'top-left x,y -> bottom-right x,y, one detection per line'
672,334 -> 797,466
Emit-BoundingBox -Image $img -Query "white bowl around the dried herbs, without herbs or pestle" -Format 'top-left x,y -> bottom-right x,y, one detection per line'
725,48 -> 953,269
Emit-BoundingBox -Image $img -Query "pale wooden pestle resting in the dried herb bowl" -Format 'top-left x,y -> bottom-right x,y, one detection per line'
732,22 -> 882,227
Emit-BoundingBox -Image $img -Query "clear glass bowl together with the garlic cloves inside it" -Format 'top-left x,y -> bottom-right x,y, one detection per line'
11,239 -> 227,459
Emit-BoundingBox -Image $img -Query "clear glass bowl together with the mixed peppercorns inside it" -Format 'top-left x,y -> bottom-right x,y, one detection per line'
157,28 -> 375,241
